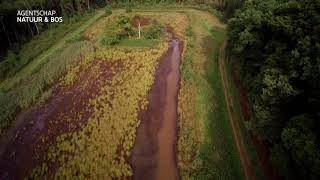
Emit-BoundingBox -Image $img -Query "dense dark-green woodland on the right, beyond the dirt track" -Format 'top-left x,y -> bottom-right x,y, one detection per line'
228,0 -> 320,179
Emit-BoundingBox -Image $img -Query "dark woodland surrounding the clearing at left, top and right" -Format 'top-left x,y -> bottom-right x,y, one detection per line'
0,0 -> 320,179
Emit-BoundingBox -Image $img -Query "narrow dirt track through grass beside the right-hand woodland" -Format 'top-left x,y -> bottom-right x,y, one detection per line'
219,43 -> 256,180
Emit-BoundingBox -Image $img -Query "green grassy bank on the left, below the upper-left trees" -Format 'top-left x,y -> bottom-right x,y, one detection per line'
0,11 -> 105,134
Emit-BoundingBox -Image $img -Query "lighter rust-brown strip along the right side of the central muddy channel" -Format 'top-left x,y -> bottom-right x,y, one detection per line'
156,40 -> 180,180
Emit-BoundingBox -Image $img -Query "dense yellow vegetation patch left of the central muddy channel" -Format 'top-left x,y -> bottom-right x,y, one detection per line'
33,43 -> 167,179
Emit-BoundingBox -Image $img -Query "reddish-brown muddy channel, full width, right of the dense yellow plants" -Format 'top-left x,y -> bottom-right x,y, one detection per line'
130,38 -> 183,180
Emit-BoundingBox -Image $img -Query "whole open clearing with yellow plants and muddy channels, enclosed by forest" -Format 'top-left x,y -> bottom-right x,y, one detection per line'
0,9 -> 256,180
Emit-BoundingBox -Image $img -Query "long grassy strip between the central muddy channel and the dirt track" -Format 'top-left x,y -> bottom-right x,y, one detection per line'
178,10 -> 243,179
